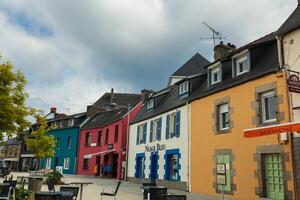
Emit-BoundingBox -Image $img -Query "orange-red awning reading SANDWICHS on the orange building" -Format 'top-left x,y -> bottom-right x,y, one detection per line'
244,122 -> 300,138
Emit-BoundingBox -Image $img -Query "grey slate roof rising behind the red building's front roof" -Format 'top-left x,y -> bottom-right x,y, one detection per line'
94,92 -> 142,108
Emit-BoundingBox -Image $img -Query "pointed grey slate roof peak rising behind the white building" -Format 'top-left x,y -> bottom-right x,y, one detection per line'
172,53 -> 210,76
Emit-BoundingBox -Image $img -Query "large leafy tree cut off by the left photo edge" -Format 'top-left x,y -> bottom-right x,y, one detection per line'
0,62 -> 36,140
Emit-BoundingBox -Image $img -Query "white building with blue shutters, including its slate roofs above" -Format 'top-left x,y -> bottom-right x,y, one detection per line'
127,54 -> 208,190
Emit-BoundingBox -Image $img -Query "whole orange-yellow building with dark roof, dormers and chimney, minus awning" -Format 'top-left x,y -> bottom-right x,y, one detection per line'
190,33 -> 294,200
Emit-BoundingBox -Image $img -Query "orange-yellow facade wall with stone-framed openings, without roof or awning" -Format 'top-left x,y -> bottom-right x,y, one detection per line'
191,73 -> 293,200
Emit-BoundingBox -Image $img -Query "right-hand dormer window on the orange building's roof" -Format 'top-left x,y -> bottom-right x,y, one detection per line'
232,51 -> 250,76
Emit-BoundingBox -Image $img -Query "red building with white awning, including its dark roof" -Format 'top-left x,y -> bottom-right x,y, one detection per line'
77,94 -> 142,179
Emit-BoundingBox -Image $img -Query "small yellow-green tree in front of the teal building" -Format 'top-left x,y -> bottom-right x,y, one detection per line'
25,115 -> 54,170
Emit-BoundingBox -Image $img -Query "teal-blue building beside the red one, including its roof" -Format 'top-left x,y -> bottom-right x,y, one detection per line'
41,112 -> 88,174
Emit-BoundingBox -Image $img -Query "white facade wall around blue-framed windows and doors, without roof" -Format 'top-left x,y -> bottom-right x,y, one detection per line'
127,105 -> 189,190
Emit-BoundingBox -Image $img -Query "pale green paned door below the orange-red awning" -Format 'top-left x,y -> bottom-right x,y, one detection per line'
262,153 -> 284,200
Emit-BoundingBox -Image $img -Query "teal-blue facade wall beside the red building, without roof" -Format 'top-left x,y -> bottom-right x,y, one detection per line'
41,128 -> 79,174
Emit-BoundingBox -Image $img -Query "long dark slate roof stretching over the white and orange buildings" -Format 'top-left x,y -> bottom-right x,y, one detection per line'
131,33 -> 280,124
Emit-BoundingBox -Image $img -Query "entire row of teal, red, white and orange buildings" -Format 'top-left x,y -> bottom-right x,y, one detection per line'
7,3 -> 300,200
